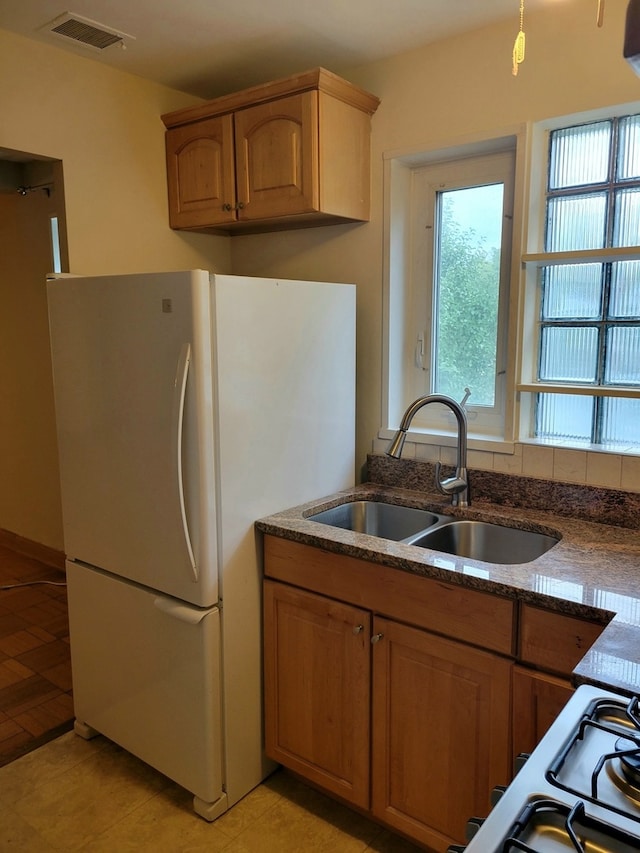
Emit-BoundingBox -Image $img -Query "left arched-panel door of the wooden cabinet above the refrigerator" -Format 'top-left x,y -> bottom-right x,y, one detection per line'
166,115 -> 236,228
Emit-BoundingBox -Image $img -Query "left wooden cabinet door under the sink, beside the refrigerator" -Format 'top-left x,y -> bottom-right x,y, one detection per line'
264,581 -> 370,808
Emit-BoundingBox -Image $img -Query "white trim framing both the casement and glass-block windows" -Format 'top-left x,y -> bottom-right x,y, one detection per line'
378,110 -> 640,462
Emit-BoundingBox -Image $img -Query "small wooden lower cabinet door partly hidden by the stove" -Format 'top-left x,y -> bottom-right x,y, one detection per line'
513,666 -> 573,758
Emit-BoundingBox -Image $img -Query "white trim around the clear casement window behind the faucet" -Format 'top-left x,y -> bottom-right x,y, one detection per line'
378,125 -> 530,453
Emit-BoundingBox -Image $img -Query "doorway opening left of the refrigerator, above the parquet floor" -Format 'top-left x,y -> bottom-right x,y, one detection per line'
0,148 -> 69,568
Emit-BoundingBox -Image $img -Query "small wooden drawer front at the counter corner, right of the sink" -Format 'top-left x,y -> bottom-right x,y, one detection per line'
519,604 -> 605,675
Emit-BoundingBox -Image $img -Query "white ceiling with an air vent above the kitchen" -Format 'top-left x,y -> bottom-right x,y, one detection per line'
0,0 -> 556,98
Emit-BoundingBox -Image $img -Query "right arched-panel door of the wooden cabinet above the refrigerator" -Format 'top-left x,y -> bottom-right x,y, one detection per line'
235,92 -> 319,220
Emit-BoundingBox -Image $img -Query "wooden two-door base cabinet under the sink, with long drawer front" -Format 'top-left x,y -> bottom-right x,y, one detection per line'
264,536 -> 513,853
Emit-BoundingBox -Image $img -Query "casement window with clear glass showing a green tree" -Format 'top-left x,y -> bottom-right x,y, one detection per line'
406,152 -> 514,435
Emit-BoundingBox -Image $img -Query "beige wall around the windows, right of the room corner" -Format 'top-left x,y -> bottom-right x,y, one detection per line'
231,0 -> 640,485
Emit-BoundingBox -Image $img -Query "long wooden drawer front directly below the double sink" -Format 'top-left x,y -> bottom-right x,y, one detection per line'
264,535 -> 514,655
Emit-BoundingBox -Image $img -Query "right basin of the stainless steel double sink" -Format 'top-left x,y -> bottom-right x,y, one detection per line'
411,519 -> 560,564
